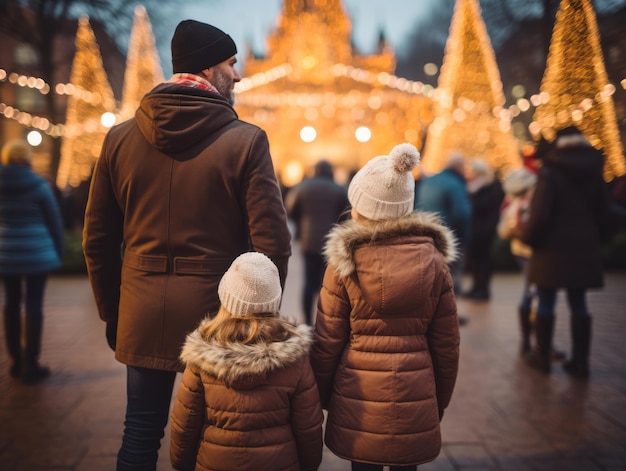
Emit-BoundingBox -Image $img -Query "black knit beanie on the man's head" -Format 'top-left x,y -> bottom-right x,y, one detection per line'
172,20 -> 237,74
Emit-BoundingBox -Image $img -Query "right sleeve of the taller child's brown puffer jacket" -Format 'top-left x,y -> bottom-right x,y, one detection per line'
428,262 -> 460,411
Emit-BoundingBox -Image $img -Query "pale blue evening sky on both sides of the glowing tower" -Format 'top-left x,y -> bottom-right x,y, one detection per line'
162,0 -> 437,75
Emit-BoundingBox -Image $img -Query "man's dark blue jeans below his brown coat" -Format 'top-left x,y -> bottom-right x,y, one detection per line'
117,366 -> 176,471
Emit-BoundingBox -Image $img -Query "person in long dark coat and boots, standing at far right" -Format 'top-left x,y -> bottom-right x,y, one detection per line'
520,126 -> 610,378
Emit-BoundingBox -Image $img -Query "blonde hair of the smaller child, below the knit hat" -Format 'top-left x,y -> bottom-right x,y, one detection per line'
199,307 -> 298,345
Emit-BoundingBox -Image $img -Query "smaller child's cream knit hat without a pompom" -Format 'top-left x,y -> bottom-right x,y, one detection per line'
217,252 -> 282,316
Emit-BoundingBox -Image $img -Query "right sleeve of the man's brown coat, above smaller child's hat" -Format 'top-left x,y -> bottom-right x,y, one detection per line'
242,129 -> 291,287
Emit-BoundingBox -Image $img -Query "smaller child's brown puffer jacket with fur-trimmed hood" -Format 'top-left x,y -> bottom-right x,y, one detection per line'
170,321 -> 323,471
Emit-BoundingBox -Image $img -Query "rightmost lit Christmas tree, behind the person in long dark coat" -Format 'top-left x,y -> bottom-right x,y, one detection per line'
529,0 -> 626,181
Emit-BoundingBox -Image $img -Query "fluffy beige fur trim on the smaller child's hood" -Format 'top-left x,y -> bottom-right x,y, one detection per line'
180,319 -> 313,390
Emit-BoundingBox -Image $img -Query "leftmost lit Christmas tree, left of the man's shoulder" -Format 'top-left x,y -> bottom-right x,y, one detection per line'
57,16 -> 115,188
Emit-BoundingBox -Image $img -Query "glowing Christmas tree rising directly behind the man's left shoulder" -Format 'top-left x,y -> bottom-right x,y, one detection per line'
120,5 -> 163,120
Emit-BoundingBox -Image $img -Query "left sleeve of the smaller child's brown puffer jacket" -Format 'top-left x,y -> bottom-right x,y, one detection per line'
170,366 -> 205,471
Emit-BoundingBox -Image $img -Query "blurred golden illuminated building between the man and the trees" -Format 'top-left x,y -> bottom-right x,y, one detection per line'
235,0 -> 432,186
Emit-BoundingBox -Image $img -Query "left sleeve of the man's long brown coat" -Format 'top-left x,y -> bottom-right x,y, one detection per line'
83,134 -> 124,322
